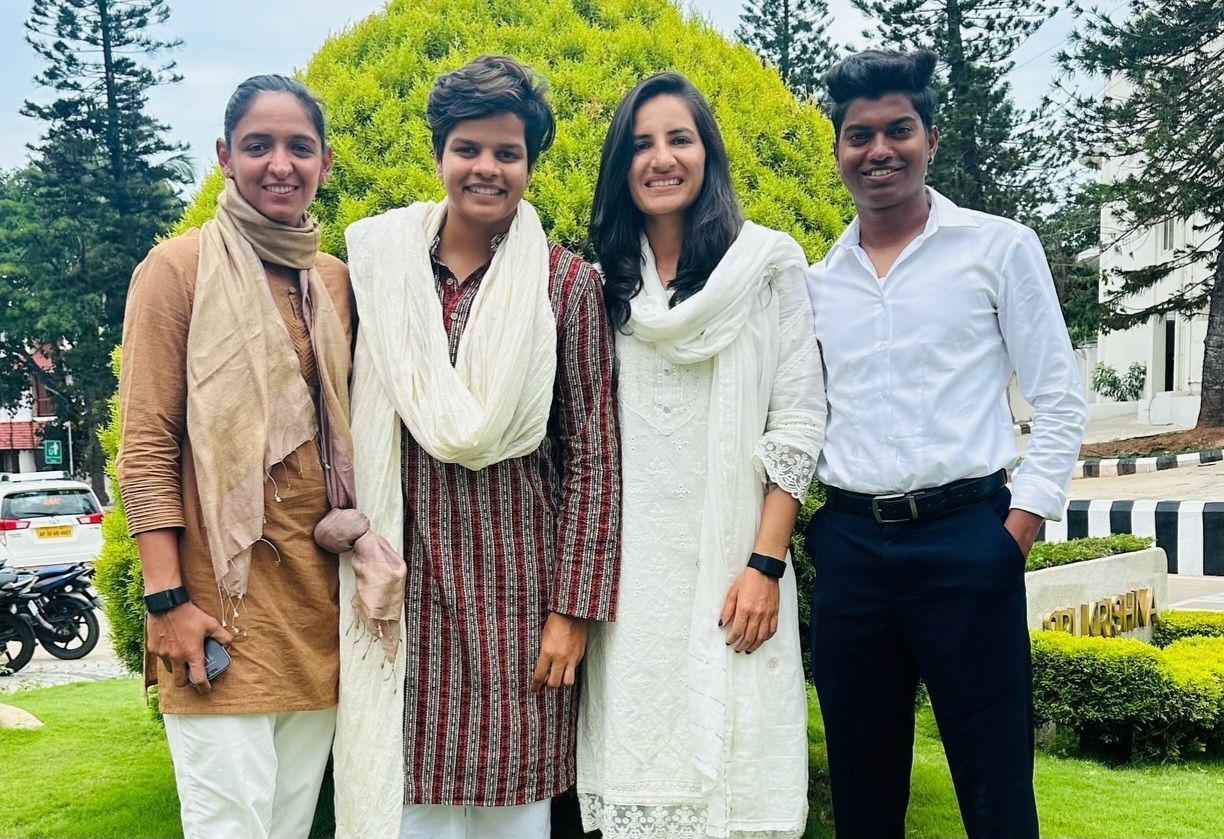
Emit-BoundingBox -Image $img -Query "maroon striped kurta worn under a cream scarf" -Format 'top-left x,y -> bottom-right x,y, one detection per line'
403,235 -> 621,806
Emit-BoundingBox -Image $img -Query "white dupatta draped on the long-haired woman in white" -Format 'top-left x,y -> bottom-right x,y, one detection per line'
628,222 -> 807,835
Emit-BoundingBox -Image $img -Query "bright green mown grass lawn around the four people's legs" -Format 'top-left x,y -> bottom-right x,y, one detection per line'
0,680 -> 1224,839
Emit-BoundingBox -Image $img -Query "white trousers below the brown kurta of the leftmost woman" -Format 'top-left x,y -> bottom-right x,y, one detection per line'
165,708 -> 335,839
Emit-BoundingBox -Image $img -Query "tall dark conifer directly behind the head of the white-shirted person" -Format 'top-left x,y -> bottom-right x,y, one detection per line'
852,0 -> 1058,222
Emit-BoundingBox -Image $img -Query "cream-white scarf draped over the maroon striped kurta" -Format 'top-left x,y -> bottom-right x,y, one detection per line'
334,201 -> 557,839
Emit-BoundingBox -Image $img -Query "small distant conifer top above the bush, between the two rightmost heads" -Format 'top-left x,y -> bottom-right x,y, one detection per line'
736,0 -> 838,98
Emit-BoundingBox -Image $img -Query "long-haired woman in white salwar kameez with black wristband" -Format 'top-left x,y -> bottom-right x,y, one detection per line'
578,73 -> 825,839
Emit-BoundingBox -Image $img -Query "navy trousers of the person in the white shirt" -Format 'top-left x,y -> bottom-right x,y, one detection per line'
805,489 -> 1038,839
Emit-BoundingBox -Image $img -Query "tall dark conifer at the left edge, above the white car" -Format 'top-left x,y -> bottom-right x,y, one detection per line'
0,0 -> 191,491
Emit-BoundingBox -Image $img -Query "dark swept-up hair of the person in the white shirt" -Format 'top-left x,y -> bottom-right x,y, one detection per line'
825,49 -> 939,137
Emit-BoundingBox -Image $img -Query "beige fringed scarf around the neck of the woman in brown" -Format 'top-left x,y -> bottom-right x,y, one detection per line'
187,181 -> 404,657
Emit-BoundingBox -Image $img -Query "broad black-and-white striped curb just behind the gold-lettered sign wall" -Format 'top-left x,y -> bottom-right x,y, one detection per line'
1037,499 -> 1224,576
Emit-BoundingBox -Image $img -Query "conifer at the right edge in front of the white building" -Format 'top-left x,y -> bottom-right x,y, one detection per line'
1059,0 -> 1224,427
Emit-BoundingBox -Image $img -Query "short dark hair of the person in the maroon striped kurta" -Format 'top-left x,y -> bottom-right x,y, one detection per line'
425,55 -> 557,167
